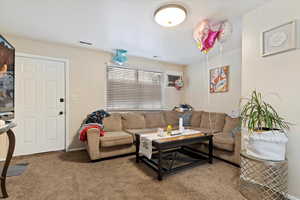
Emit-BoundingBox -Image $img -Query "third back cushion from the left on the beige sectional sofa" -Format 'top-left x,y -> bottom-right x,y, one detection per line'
144,112 -> 166,128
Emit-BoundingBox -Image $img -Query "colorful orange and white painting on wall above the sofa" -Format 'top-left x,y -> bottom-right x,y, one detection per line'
209,66 -> 229,93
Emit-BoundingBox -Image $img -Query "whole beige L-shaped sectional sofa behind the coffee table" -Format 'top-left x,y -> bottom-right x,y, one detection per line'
86,111 -> 241,165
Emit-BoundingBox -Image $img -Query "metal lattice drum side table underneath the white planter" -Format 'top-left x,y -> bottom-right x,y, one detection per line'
240,151 -> 288,200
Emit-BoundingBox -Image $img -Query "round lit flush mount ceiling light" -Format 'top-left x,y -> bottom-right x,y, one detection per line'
154,4 -> 187,27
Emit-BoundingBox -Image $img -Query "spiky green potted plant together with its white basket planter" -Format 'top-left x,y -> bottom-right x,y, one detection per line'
241,91 -> 290,161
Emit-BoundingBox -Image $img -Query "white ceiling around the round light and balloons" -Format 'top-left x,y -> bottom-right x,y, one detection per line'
0,0 -> 268,64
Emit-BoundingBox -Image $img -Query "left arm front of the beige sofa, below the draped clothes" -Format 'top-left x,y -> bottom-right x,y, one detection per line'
86,128 -> 100,160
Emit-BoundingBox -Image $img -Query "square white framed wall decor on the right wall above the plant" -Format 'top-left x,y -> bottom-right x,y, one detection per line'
261,20 -> 297,57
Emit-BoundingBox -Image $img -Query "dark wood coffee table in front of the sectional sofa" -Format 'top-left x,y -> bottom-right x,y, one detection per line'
135,132 -> 213,181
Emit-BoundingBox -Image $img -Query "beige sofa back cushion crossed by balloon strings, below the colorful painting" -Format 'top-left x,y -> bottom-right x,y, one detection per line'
200,112 -> 226,132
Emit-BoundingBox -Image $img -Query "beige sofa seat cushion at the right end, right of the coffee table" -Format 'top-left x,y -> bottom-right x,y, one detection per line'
213,133 -> 234,152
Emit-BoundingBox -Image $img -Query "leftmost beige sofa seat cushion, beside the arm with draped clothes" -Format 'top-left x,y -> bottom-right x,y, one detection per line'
100,131 -> 133,147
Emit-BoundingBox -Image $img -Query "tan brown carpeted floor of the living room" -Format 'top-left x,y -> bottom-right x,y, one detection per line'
0,151 -> 244,200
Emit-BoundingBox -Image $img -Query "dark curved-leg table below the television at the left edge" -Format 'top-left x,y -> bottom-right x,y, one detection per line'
0,123 -> 16,198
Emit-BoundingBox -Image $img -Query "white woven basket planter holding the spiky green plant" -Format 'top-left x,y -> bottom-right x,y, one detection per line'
245,130 -> 288,161
